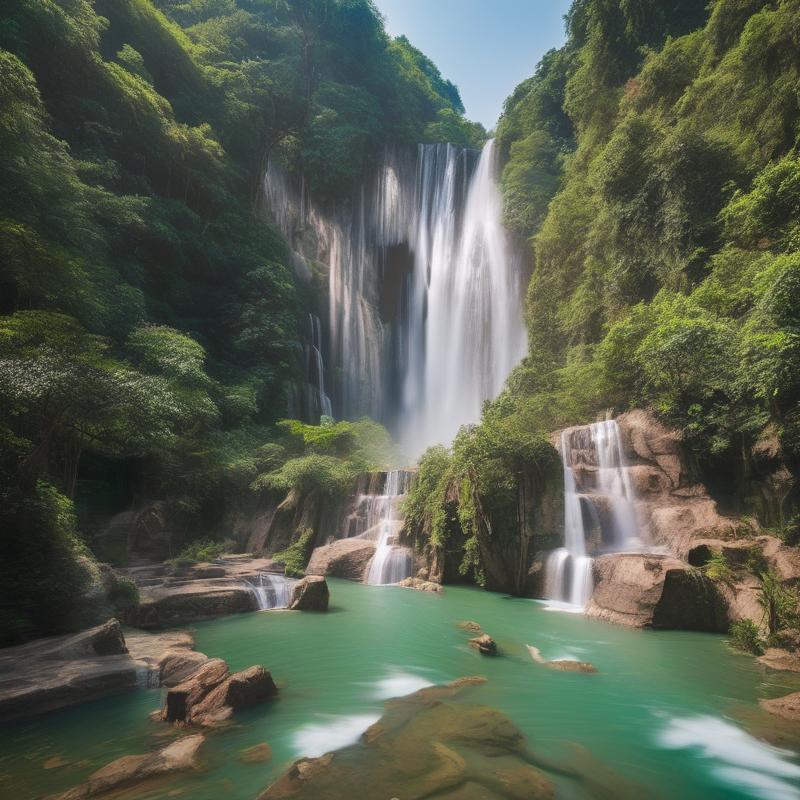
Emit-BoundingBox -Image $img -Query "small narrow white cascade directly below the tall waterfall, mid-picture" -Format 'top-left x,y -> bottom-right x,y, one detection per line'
362,470 -> 414,586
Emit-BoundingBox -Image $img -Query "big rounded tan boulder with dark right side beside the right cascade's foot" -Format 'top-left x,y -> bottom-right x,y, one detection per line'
586,553 -> 729,633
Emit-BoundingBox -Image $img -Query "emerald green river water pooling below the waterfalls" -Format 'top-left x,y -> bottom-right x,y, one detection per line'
0,580 -> 800,800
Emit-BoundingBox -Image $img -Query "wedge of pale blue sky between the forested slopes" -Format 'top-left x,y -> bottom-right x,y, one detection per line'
375,0 -> 571,128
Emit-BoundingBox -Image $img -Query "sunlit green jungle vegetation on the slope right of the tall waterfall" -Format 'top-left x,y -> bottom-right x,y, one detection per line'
407,0 -> 800,579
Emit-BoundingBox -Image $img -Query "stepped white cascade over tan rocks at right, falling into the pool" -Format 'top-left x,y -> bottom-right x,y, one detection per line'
545,420 -> 642,608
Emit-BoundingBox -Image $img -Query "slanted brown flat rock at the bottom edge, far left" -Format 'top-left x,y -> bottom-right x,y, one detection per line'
51,734 -> 205,800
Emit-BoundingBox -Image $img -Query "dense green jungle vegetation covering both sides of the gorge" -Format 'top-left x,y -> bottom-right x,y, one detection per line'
0,0 -> 800,639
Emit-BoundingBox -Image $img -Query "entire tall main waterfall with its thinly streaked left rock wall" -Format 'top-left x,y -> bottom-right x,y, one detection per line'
265,136 -> 526,456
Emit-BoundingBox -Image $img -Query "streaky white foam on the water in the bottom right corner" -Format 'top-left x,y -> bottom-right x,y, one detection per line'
658,715 -> 800,800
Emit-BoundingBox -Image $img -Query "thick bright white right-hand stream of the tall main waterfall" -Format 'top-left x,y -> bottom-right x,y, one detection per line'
401,140 -> 526,454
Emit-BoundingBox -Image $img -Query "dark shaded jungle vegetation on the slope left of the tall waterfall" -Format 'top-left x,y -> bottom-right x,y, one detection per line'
0,0 -> 484,639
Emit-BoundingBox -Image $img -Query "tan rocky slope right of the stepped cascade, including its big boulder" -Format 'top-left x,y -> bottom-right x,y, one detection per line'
587,410 -> 800,631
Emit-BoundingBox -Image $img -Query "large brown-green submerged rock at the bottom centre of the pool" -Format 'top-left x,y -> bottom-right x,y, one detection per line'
260,687 -> 555,800
